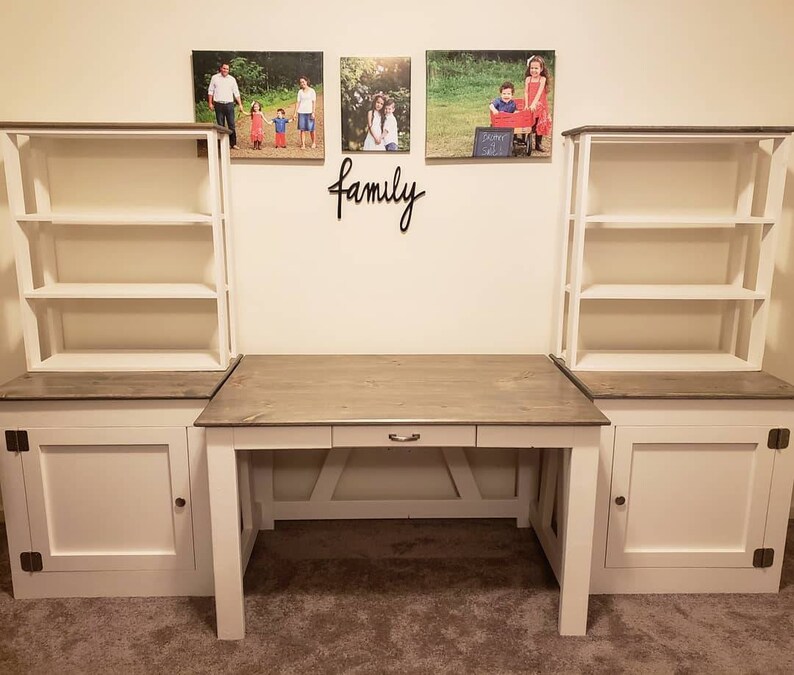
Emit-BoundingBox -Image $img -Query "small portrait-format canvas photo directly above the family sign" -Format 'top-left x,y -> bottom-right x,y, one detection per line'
339,56 -> 411,153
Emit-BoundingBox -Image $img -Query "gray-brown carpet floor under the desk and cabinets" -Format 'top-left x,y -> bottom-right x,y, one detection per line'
0,520 -> 794,674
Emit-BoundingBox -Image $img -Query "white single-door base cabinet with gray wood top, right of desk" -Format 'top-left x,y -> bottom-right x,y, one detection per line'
557,361 -> 794,593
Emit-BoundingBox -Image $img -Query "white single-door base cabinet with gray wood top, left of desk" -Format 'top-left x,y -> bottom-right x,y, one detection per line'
0,372 -> 225,598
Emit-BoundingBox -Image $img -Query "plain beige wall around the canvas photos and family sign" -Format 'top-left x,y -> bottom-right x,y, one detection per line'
0,0 -> 794,380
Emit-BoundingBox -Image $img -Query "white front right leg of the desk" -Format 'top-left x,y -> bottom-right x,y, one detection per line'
559,427 -> 600,635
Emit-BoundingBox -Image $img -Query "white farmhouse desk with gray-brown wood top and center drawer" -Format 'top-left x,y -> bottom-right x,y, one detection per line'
196,355 -> 609,640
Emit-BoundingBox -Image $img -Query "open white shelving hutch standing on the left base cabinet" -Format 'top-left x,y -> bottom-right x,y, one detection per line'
0,123 -> 235,372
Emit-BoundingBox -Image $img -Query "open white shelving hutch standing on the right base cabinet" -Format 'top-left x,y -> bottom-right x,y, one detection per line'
554,127 -> 794,371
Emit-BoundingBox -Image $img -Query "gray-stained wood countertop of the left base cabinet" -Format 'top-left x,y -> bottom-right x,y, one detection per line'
0,359 -> 239,401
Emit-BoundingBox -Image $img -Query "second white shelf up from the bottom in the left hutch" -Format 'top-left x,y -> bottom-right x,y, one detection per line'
25,283 -> 218,300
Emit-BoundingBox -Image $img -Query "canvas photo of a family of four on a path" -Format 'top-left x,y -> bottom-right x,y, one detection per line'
193,51 -> 325,159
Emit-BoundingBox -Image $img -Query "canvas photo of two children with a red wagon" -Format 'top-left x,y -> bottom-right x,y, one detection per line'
425,50 -> 556,159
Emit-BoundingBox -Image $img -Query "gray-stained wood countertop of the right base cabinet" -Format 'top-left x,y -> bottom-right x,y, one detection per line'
552,357 -> 794,400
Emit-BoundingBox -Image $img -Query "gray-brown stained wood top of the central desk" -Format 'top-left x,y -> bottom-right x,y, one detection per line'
196,355 -> 609,427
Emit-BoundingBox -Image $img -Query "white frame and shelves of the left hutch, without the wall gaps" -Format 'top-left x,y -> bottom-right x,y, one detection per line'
0,126 -> 234,371
